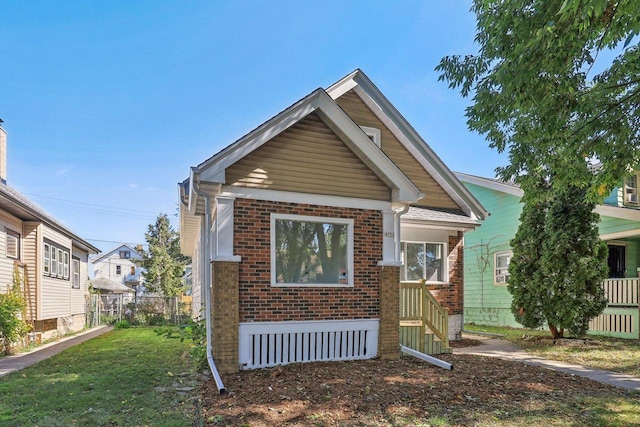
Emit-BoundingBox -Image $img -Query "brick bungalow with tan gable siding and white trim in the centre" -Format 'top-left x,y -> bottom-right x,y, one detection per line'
179,70 -> 486,378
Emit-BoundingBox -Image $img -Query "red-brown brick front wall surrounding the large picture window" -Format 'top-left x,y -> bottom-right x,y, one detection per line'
234,198 -> 382,322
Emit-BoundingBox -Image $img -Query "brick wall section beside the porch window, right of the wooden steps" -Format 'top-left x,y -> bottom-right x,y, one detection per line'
427,232 -> 464,315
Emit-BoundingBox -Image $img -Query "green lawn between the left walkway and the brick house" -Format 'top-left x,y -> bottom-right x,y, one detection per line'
0,328 -> 197,426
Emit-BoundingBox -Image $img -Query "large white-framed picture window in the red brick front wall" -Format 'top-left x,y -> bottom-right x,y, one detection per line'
271,214 -> 353,286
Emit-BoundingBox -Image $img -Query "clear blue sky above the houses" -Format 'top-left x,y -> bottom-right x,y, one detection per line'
0,0 -> 506,252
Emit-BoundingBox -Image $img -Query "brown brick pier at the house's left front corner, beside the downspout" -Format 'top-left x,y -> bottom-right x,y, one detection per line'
211,262 -> 239,373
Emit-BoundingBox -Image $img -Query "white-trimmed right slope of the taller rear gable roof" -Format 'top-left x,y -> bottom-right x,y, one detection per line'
327,69 -> 488,219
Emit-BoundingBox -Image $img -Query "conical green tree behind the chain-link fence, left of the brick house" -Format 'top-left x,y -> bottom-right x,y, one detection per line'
136,213 -> 189,296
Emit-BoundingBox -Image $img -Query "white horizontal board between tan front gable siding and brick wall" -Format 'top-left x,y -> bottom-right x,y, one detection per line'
220,185 -> 392,211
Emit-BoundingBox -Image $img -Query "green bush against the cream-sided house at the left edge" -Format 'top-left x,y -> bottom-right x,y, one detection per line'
0,270 -> 30,354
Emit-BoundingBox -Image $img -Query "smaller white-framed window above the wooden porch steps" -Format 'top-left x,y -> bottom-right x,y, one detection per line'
400,242 -> 446,282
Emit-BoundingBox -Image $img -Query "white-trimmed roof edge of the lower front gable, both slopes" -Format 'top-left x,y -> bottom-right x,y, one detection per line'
188,89 -> 421,212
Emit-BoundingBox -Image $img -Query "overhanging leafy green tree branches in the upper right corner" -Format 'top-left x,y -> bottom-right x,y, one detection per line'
437,0 -> 640,200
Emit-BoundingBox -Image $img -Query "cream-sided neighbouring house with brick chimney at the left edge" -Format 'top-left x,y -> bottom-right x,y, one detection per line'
0,123 -> 99,339
